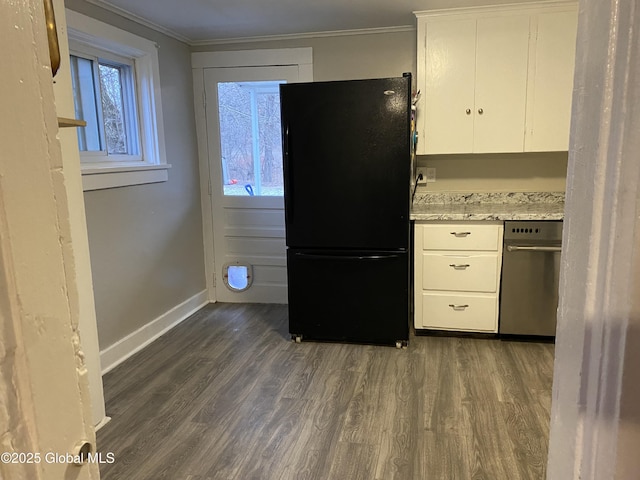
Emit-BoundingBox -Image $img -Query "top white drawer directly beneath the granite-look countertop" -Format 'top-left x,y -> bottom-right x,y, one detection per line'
422,224 -> 500,251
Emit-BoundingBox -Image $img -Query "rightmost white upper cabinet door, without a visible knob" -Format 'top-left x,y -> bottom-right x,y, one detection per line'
525,8 -> 578,152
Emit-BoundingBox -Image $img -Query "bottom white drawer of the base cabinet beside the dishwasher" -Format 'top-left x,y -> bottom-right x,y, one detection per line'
422,292 -> 498,332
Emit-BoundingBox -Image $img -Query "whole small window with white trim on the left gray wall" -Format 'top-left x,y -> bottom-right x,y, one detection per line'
66,10 -> 170,190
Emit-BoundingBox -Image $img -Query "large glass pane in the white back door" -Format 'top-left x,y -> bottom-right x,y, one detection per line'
218,81 -> 284,196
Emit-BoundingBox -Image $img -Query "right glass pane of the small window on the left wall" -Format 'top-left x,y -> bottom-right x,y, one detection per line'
100,63 -> 131,155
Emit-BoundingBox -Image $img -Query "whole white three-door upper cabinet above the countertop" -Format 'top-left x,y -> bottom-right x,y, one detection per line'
416,2 -> 577,154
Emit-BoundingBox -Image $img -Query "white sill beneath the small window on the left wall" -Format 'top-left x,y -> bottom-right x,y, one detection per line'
82,163 -> 171,192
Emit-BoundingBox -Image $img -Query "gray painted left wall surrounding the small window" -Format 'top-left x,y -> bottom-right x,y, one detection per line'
65,0 -> 206,350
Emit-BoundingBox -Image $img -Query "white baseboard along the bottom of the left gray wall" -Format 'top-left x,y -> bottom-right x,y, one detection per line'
100,290 -> 209,375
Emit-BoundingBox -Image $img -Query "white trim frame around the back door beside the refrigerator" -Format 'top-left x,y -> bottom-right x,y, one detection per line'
191,47 -> 313,302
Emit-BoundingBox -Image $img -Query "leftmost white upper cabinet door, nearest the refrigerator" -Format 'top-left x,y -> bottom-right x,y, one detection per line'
418,19 -> 476,153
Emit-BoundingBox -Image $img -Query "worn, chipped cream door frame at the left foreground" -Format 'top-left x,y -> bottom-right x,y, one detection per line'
0,0 -> 100,480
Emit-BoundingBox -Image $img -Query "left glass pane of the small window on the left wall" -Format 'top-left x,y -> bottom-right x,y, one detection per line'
70,55 -> 102,152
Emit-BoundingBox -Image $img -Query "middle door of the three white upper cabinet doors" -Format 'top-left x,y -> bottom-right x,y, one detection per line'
473,15 -> 529,153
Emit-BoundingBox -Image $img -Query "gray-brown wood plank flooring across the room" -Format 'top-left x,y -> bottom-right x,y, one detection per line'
98,304 -> 553,480
